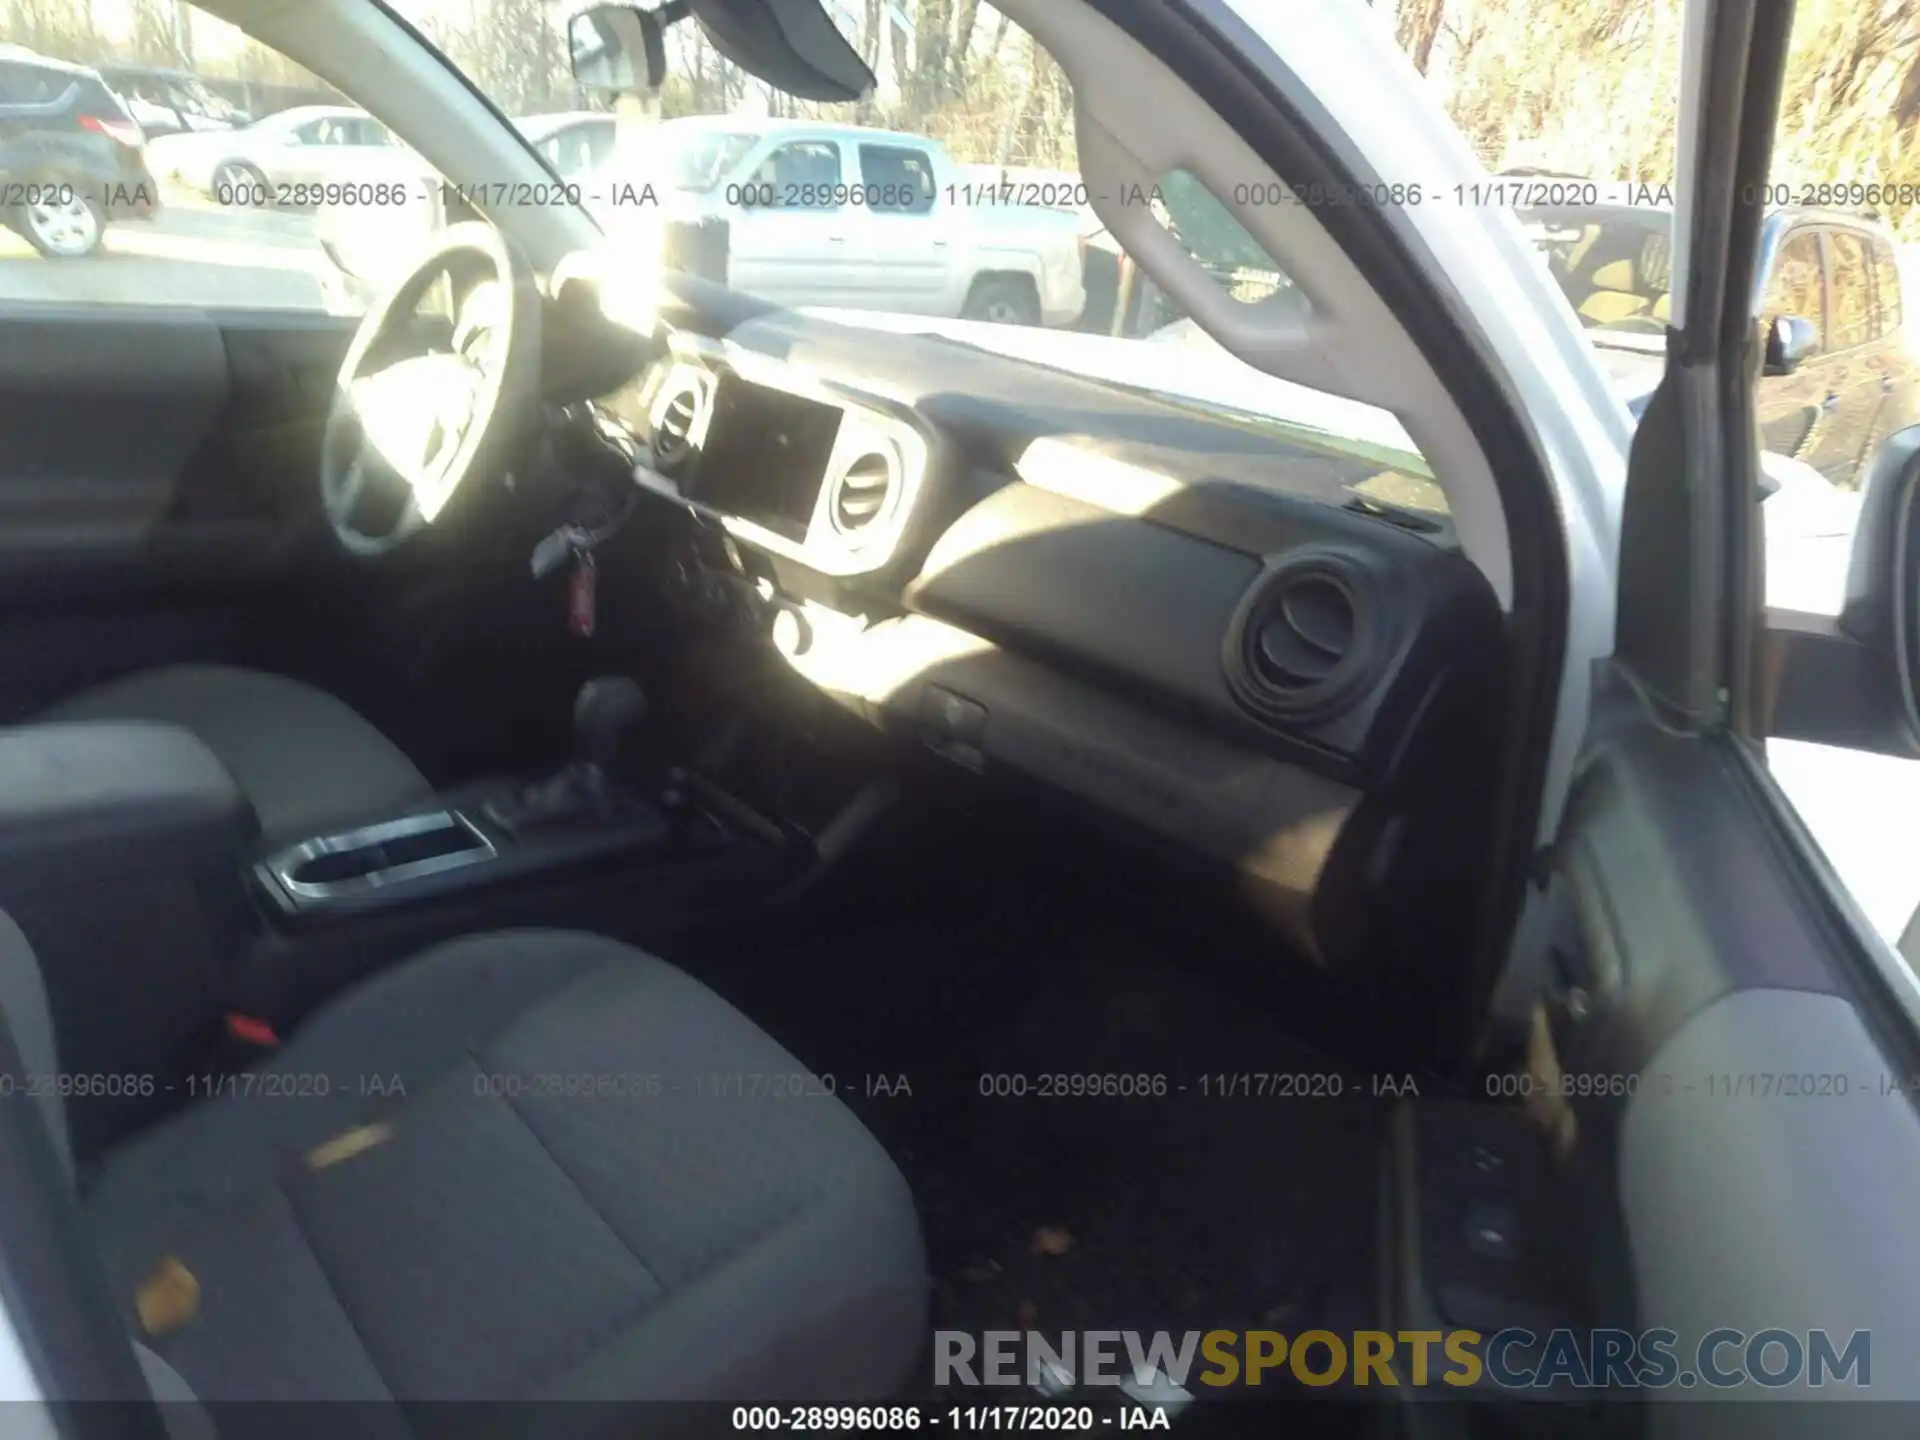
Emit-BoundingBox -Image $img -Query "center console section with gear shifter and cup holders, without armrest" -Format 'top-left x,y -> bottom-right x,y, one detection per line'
228,678 -> 816,1029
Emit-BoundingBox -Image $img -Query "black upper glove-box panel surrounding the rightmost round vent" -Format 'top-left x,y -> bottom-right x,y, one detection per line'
904,482 -> 1500,789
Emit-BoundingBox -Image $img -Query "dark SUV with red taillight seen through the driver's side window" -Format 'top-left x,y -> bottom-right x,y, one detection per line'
0,46 -> 159,259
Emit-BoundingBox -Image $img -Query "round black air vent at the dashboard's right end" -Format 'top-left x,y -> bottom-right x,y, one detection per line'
1225,549 -> 1380,720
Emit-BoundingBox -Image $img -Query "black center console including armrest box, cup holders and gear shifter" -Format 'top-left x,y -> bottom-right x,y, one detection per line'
0,678 -> 818,1154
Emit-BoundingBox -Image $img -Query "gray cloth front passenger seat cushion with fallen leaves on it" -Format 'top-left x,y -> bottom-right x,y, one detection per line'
0,916 -> 927,1413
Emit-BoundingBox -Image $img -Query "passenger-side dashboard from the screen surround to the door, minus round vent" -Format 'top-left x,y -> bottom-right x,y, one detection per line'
583,315 -> 1505,970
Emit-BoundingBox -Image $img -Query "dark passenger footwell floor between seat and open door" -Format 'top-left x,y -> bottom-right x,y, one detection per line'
712,879 -> 1388,1397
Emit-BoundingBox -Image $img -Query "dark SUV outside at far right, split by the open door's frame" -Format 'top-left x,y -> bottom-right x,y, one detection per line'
1521,204 -> 1920,490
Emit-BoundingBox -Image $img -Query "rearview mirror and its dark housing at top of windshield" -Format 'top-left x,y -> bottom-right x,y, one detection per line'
566,0 -> 874,102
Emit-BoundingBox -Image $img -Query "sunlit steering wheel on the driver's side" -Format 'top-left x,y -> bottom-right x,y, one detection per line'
321,221 -> 540,557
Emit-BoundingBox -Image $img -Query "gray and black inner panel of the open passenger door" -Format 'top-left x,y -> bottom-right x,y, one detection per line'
1553,722 -> 1920,1413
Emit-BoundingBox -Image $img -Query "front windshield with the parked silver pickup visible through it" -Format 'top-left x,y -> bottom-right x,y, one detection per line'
366,0 -> 1425,499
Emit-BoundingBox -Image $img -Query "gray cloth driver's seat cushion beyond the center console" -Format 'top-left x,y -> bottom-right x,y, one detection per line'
36,664 -> 432,841
